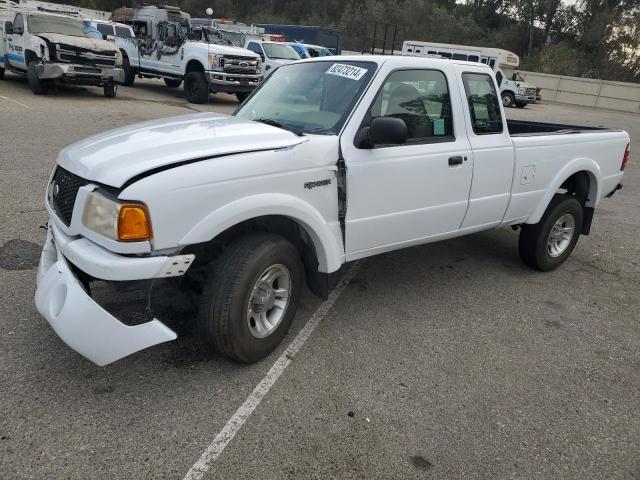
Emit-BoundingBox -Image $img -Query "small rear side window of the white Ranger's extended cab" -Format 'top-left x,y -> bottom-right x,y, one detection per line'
462,73 -> 502,135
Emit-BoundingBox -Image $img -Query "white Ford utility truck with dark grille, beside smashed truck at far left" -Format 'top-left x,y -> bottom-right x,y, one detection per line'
111,6 -> 262,103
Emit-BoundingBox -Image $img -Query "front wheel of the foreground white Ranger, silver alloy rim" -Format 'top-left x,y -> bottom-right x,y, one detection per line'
199,232 -> 303,363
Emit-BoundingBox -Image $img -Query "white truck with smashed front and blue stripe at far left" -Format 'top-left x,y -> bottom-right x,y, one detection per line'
0,1 -> 124,97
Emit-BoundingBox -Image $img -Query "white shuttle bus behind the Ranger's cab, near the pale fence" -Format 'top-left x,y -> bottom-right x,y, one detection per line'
402,40 -> 536,108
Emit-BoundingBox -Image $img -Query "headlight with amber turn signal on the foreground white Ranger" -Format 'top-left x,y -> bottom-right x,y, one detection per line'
82,192 -> 151,242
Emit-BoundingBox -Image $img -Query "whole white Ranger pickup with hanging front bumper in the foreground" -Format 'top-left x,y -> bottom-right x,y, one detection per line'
36,56 -> 629,365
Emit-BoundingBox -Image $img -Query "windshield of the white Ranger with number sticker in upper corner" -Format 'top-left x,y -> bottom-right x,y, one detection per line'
234,61 -> 376,135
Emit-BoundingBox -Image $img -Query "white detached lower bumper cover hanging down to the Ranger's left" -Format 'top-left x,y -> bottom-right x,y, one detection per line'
35,230 -> 177,366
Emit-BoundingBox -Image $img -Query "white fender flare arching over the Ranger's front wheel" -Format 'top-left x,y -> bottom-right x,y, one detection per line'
179,193 -> 344,273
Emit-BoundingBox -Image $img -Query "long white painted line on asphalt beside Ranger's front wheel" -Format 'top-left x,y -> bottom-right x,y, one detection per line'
183,260 -> 363,480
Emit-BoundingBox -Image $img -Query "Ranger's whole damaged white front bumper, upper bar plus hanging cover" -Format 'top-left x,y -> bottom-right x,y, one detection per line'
35,225 -> 193,366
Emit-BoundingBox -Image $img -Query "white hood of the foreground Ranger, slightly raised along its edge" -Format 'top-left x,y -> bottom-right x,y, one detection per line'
58,113 -> 305,188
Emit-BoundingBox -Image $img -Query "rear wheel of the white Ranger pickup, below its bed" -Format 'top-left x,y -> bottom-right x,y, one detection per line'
518,194 -> 583,272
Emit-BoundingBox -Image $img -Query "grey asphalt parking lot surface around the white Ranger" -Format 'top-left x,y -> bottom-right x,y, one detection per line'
0,74 -> 640,480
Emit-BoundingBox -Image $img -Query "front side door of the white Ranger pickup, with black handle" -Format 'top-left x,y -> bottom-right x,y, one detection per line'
341,66 -> 473,260
